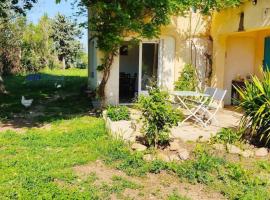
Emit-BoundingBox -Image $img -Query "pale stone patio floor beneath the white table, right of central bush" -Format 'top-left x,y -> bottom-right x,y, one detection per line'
172,108 -> 242,142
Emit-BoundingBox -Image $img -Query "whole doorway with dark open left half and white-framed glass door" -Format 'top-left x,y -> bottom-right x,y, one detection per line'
119,42 -> 159,104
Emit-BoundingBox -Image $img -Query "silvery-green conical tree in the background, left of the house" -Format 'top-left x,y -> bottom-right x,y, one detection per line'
51,14 -> 81,69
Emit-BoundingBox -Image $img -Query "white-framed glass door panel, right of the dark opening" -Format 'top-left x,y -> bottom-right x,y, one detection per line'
139,42 -> 159,93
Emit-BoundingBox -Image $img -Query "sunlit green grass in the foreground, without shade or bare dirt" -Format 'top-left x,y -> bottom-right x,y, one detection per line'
0,117 -> 270,200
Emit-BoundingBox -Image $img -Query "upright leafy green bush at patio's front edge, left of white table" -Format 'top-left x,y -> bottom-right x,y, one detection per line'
137,86 -> 181,147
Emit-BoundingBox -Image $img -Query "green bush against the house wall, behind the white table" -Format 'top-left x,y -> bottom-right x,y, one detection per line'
175,64 -> 198,91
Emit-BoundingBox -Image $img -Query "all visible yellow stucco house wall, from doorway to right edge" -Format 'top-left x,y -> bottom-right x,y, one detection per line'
90,0 -> 270,104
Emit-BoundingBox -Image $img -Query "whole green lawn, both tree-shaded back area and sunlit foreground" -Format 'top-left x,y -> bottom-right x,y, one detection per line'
0,69 -> 270,200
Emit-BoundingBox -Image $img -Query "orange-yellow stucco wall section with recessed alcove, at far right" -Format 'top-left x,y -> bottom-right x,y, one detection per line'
211,0 -> 270,104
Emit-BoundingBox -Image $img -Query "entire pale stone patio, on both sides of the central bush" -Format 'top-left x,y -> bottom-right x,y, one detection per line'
104,108 -> 242,142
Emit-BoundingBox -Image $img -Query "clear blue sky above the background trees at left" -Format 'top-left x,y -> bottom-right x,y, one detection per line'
27,0 -> 87,49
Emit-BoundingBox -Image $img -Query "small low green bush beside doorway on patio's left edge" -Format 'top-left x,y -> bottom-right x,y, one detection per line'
107,106 -> 130,121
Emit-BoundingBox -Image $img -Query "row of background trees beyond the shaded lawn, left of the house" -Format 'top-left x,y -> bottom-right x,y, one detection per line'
0,10 -> 88,92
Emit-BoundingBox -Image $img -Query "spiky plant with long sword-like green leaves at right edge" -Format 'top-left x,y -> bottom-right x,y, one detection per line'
237,71 -> 270,145
